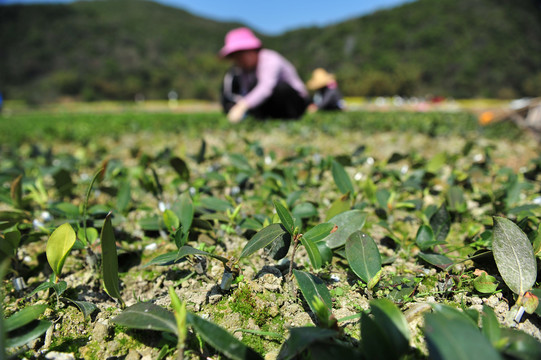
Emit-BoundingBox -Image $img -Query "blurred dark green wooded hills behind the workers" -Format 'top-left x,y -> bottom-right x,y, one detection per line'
0,0 -> 541,102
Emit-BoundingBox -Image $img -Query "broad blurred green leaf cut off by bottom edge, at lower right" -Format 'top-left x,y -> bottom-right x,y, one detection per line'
424,305 -> 501,360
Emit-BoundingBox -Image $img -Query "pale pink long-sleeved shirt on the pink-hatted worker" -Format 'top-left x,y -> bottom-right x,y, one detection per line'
242,49 -> 308,108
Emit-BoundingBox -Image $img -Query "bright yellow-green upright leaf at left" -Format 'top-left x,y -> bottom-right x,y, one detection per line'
45,223 -> 76,278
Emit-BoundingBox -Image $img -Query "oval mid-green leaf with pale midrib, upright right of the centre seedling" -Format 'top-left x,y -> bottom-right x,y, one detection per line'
346,231 -> 381,283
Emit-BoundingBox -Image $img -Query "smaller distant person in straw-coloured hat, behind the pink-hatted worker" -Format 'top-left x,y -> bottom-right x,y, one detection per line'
306,68 -> 345,112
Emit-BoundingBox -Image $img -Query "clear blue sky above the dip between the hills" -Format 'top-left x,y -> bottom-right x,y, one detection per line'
0,0 -> 412,35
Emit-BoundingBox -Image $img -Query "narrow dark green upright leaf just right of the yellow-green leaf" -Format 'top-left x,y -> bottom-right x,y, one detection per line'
100,213 -> 124,307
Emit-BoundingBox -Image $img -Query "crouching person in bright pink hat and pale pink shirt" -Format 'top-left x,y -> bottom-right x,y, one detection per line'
220,27 -> 309,123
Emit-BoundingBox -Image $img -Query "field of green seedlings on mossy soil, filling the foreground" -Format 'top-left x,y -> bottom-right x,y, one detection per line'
0,111 -> 541,360
